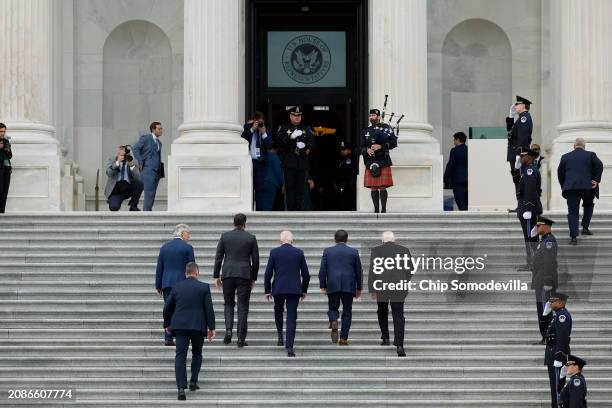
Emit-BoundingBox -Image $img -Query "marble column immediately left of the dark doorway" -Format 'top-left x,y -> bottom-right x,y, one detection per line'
168,0 -> 253,211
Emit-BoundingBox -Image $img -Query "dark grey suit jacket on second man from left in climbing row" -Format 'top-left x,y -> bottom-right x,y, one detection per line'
213,228 -> 259,281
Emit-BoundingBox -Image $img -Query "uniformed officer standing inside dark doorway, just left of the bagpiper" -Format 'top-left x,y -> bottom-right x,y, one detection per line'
334,141 -> 359,211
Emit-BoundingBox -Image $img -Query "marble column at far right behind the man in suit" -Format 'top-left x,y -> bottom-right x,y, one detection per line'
550,0 -> 612,209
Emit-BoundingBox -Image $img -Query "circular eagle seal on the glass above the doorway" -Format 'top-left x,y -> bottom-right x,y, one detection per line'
282,35 -> 331,84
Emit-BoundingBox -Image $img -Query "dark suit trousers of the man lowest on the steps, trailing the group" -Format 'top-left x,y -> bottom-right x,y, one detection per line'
174,330 -> 204,390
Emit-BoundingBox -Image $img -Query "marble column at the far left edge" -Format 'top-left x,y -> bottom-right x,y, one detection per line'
0,0 -> 60,211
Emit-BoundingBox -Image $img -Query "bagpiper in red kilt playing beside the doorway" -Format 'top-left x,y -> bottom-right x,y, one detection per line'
361,109 -> 397,213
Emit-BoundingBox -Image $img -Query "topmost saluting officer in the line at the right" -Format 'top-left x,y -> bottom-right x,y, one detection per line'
506,95 -> 533,196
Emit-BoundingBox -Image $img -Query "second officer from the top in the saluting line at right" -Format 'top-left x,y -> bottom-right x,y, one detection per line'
516,149 -> 542,270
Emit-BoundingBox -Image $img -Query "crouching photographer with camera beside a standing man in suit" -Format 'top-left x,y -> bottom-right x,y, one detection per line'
104,145 -> 143,211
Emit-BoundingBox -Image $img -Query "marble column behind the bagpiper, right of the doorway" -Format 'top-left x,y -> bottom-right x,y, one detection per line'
358,0 -> 443,212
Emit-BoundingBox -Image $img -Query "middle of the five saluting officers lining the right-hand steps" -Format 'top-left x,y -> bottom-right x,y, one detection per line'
531,216 -> 558,344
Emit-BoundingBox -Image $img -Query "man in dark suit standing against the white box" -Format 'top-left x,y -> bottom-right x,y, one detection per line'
444,132 -> 468,211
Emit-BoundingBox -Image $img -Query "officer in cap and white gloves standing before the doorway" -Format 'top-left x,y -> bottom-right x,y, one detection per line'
276,106 -> 314,211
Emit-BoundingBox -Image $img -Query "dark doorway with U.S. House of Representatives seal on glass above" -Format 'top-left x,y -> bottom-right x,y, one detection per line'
246,0 -> 368,211
